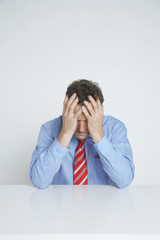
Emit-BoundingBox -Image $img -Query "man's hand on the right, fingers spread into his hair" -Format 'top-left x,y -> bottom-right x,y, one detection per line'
82,96 -> 104,143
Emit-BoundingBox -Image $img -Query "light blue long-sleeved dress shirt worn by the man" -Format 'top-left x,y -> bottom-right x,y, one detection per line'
29,115 -> 135,188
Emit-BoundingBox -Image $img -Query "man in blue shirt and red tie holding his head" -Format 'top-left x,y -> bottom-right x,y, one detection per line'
29,79 -> 135,188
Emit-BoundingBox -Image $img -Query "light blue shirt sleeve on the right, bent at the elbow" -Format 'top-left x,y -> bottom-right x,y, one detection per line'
94,124 -> 135,188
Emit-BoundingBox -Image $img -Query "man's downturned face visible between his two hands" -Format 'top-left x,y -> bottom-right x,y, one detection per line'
74,104 -> 89,140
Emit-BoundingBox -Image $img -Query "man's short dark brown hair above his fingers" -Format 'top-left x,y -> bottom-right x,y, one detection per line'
66,79 -> 104,106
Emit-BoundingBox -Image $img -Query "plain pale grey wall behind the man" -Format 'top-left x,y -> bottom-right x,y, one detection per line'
0,0 -> 160,185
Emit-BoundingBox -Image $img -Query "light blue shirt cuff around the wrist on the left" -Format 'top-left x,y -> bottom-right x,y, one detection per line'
49,138 -> 69,159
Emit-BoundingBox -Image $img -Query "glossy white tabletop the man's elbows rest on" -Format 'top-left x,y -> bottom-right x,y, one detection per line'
0,185 -> 160,239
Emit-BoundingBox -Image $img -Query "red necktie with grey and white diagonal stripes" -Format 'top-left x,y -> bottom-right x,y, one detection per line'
73,140 -> 88,185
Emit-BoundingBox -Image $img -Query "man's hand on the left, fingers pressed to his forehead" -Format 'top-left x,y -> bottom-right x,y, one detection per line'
57,93 -> 82,147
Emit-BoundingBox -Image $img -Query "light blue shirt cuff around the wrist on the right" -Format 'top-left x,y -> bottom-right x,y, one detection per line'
93,136 -> 112,156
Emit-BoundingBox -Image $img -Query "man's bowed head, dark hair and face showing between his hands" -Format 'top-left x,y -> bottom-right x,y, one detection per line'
66,79 -> 104,140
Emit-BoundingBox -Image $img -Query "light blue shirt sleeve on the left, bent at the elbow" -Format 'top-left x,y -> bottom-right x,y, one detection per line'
29,125 -> 69,188
